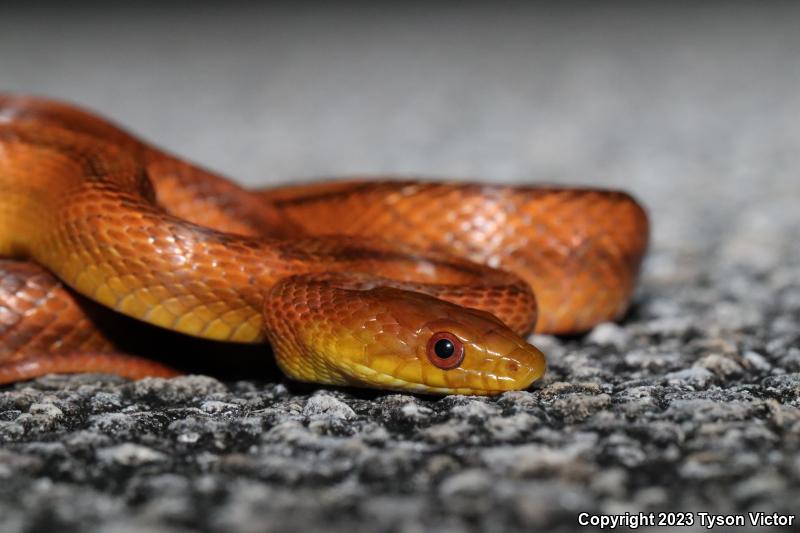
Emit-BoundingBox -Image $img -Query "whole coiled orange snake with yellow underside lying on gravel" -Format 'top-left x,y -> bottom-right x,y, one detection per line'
0,94 -> 649,395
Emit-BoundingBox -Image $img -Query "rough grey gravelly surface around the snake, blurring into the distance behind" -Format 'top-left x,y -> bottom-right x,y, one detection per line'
0,3 -> 800,533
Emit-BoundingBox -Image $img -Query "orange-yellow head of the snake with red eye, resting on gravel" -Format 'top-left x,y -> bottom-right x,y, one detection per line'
265,276 -> 545,395
